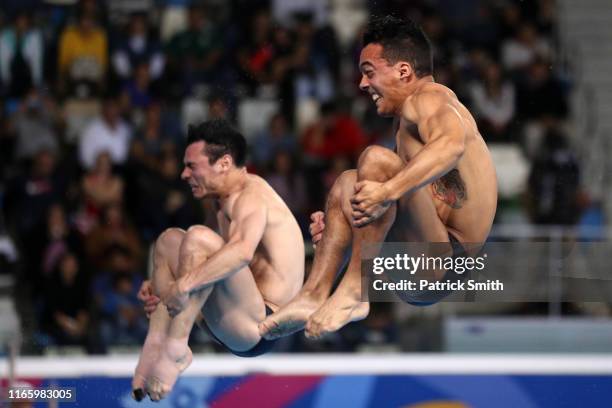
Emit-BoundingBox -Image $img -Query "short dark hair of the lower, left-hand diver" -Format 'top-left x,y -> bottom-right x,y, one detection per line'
187,119 -> 247,167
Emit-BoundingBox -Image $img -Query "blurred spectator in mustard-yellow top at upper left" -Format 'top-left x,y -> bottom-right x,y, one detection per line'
57,11 -> 108,98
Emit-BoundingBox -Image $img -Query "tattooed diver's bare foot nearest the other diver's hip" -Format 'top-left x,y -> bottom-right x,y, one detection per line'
259,293 -> 325,340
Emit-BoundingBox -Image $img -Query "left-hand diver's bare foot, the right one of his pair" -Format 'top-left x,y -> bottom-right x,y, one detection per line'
146,339 -> 193,401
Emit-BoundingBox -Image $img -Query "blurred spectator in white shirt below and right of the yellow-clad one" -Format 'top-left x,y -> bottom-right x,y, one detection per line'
79,96 -> 131,169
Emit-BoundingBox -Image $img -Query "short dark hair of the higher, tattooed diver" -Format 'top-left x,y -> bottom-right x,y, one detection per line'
363,16 -> 433,77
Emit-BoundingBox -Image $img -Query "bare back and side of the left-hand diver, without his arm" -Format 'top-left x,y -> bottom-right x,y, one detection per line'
221,174 -> 305,310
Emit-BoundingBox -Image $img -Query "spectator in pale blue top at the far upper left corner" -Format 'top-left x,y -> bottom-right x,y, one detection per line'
0,11 -> 44,98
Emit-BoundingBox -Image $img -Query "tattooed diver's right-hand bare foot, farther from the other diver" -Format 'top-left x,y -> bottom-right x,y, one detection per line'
304,288 -> 370,339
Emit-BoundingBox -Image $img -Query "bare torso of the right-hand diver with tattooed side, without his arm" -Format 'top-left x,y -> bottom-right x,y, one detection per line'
396,83 -> 497,242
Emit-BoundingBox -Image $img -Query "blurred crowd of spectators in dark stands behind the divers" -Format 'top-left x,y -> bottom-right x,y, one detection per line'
0,0 -> 581,352
